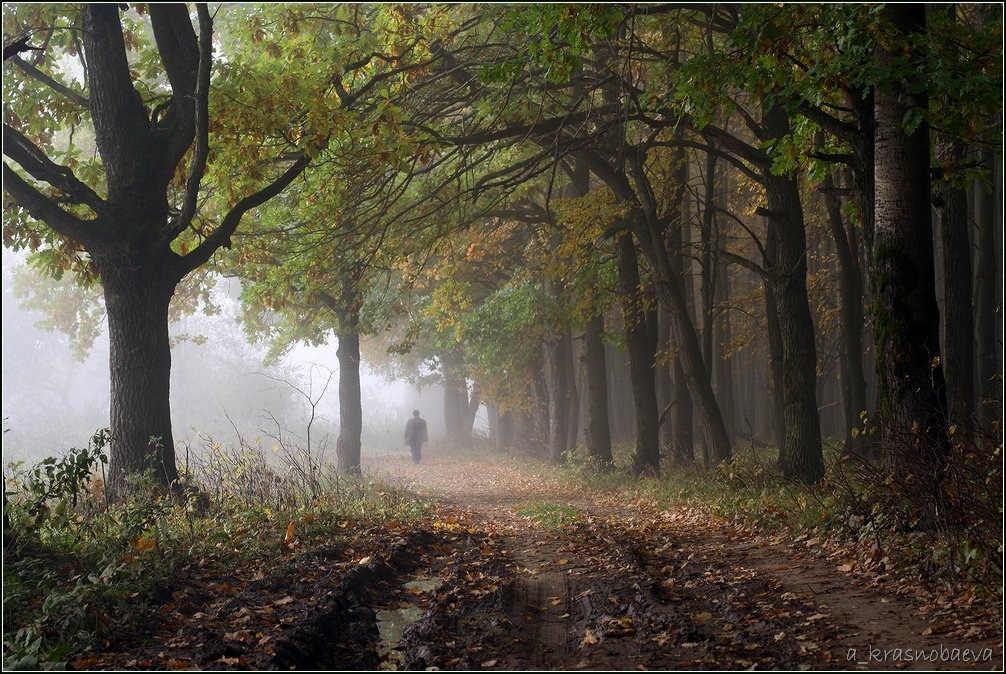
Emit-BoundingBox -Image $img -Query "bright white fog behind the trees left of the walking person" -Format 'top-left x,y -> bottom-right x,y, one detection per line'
2,261 -> 466,465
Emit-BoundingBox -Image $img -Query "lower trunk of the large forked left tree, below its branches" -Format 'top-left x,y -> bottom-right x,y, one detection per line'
99,250 -> 178,494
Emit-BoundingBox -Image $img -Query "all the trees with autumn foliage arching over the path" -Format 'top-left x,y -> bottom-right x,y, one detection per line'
4,4 -> 1002,492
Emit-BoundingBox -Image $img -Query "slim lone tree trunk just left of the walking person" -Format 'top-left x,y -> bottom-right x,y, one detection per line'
335,313 -> 363,475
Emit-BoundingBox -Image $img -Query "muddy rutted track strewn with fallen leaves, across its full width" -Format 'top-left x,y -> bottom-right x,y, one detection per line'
82,453 -> 1003,670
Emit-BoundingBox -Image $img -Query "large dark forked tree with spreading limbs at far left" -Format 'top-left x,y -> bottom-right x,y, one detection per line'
3,4 -> 308,489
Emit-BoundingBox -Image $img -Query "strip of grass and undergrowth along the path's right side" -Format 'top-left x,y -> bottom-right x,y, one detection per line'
564,436 -> 1003,599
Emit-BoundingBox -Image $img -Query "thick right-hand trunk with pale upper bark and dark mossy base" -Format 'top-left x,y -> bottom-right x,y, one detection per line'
872,4 -> 949,490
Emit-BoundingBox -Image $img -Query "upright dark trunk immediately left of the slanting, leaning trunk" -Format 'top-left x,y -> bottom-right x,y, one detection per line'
616,231 -> 660,475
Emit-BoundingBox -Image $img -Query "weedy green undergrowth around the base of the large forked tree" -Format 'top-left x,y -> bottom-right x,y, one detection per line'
3,432 -> 426,670
